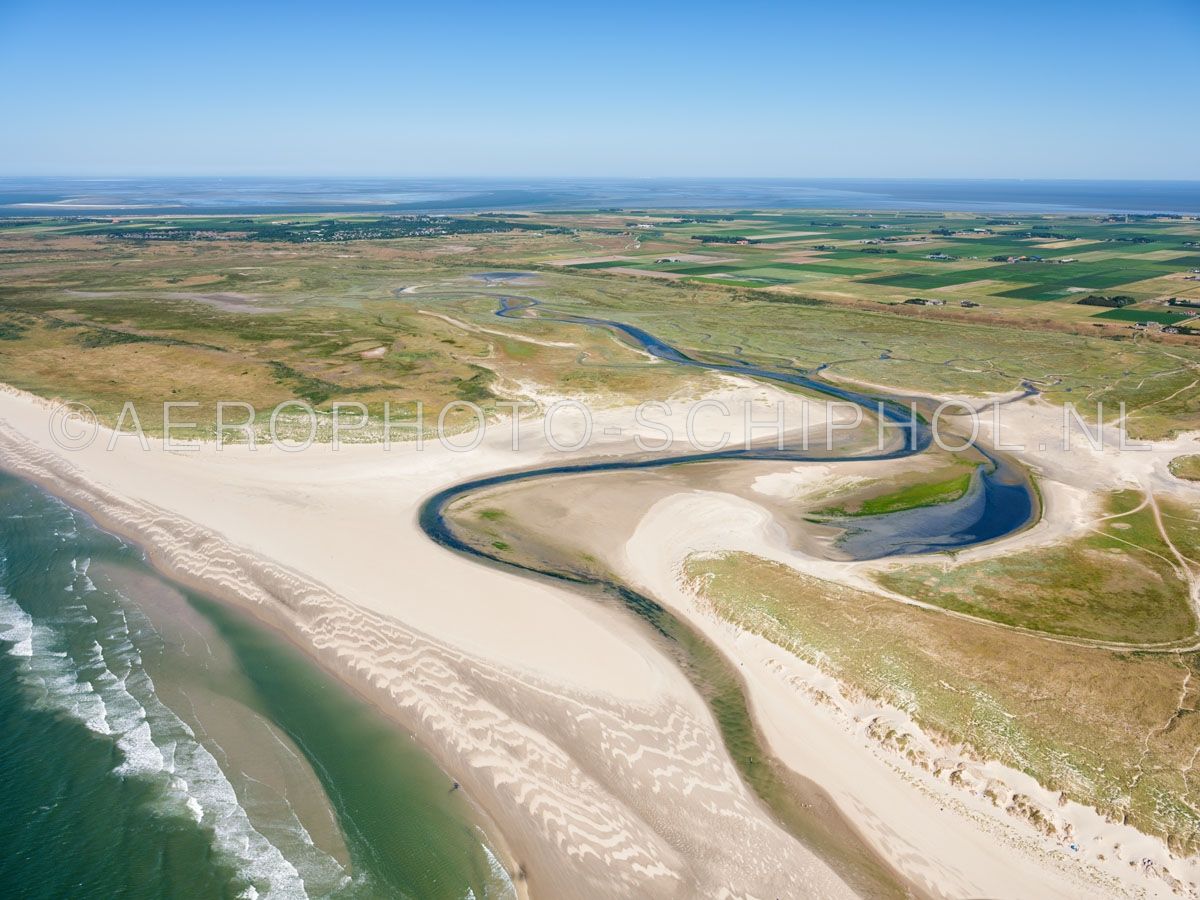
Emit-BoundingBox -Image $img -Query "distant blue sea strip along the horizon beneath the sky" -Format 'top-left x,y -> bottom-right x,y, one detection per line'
0,176 -> 1200,217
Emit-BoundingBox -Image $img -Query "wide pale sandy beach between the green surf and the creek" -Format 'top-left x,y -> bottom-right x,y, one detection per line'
0,383 -> 850,896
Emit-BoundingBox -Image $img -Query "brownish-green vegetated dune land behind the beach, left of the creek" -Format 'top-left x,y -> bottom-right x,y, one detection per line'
0,229 -> 696,439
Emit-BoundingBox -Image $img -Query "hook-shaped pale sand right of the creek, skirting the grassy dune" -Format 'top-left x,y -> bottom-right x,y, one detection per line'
611,491 -> 1200,898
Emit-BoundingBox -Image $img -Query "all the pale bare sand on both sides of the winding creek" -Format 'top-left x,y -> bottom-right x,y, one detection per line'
0,379 -> 1195,898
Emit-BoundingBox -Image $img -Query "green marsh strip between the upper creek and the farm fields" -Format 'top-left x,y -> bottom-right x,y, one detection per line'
537,264 -> 1200,438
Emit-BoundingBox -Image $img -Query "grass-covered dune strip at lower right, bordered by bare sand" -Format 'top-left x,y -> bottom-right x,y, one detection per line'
686,553 -> 1200,853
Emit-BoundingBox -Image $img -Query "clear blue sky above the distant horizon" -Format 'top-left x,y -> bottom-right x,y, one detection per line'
0,0 -> 1200,179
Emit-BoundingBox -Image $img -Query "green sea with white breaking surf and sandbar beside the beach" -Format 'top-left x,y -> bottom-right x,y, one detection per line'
0,474 -> 516,900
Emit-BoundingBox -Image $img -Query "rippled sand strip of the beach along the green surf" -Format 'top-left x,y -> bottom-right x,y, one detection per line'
0,425 -> 850,898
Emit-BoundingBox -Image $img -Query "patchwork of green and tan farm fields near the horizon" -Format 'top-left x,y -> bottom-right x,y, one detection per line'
532,211 -> 1200,330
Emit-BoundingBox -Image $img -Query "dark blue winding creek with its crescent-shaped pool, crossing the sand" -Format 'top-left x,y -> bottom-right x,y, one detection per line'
419,294 -> 1040,896
